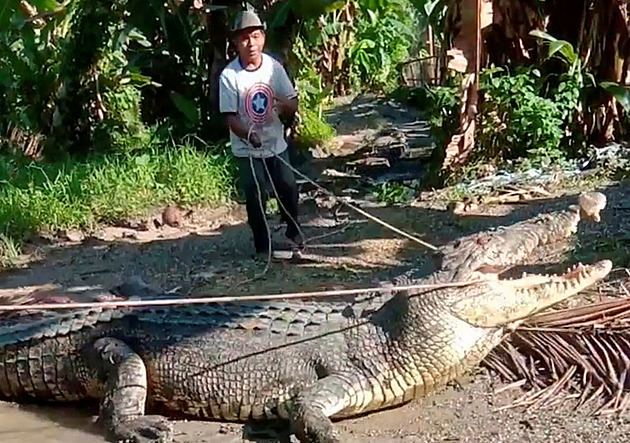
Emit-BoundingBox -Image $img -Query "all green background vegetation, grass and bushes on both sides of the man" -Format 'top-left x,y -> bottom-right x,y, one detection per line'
0,0 -> 630,268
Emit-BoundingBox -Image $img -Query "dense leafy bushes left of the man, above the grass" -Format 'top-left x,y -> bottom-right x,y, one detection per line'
0,0 -> 225,155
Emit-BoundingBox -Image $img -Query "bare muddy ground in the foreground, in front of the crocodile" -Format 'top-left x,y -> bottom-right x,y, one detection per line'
0,373 -> 630,443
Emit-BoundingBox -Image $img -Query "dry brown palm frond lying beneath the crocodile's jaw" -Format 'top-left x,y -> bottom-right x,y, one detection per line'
484,280 -> 630,414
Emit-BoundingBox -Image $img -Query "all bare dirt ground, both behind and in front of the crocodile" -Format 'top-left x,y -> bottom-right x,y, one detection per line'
0,95 -> 630,443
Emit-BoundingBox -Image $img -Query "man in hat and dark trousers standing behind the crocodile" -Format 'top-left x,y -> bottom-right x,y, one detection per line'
219,11 -> 303,254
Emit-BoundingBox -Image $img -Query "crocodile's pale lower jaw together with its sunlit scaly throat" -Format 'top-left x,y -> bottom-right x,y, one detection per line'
398,260 -> 612,395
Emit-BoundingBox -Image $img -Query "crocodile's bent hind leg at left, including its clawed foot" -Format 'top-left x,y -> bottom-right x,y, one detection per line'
86,337 -> 173,443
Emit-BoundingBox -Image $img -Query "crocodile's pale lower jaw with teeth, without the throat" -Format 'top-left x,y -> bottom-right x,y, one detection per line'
448,260 -> 612,328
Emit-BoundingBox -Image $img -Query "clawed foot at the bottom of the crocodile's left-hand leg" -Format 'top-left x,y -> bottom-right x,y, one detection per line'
110,415 -> 173,443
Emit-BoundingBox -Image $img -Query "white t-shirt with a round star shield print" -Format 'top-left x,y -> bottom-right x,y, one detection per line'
219,54 -> 297,157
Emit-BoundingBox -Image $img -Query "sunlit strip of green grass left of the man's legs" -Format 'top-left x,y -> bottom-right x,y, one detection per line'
0,145 -> 234,253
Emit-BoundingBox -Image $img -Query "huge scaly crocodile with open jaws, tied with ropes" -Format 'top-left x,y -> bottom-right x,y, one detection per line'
0,194 -> 612,443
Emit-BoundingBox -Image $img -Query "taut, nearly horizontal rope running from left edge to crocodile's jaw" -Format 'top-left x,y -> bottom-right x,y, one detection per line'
0,280 -> 482,312
